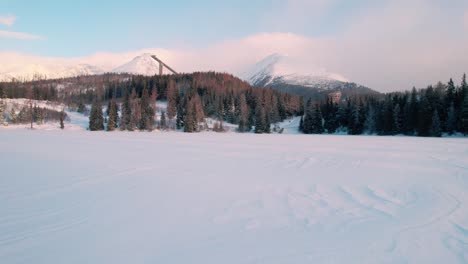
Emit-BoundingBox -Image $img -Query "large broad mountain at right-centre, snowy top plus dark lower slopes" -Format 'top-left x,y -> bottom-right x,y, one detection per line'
241,54 -> 378,100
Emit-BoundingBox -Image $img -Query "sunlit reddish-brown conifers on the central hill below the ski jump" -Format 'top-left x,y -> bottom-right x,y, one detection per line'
88,72 -> 303,133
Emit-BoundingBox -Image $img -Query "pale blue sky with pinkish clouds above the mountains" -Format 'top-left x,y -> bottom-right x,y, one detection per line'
0,0 -> 468,91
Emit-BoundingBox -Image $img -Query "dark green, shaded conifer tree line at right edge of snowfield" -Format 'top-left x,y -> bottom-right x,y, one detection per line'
299,74 -> 468,137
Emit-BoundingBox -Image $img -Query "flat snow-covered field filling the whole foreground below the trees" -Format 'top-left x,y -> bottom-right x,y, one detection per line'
0,130 -> 468,264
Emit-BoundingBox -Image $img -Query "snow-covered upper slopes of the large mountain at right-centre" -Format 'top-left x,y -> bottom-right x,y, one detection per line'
242,54 -> 348,89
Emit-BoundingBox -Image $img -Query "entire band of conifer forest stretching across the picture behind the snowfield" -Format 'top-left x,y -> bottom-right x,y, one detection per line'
0,72 -> 468,137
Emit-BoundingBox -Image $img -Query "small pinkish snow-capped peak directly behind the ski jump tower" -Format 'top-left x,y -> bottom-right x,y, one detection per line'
112,53 -> 163,76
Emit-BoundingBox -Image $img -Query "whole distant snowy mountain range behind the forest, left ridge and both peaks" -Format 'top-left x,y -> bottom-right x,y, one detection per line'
0,53 -> 378,100
